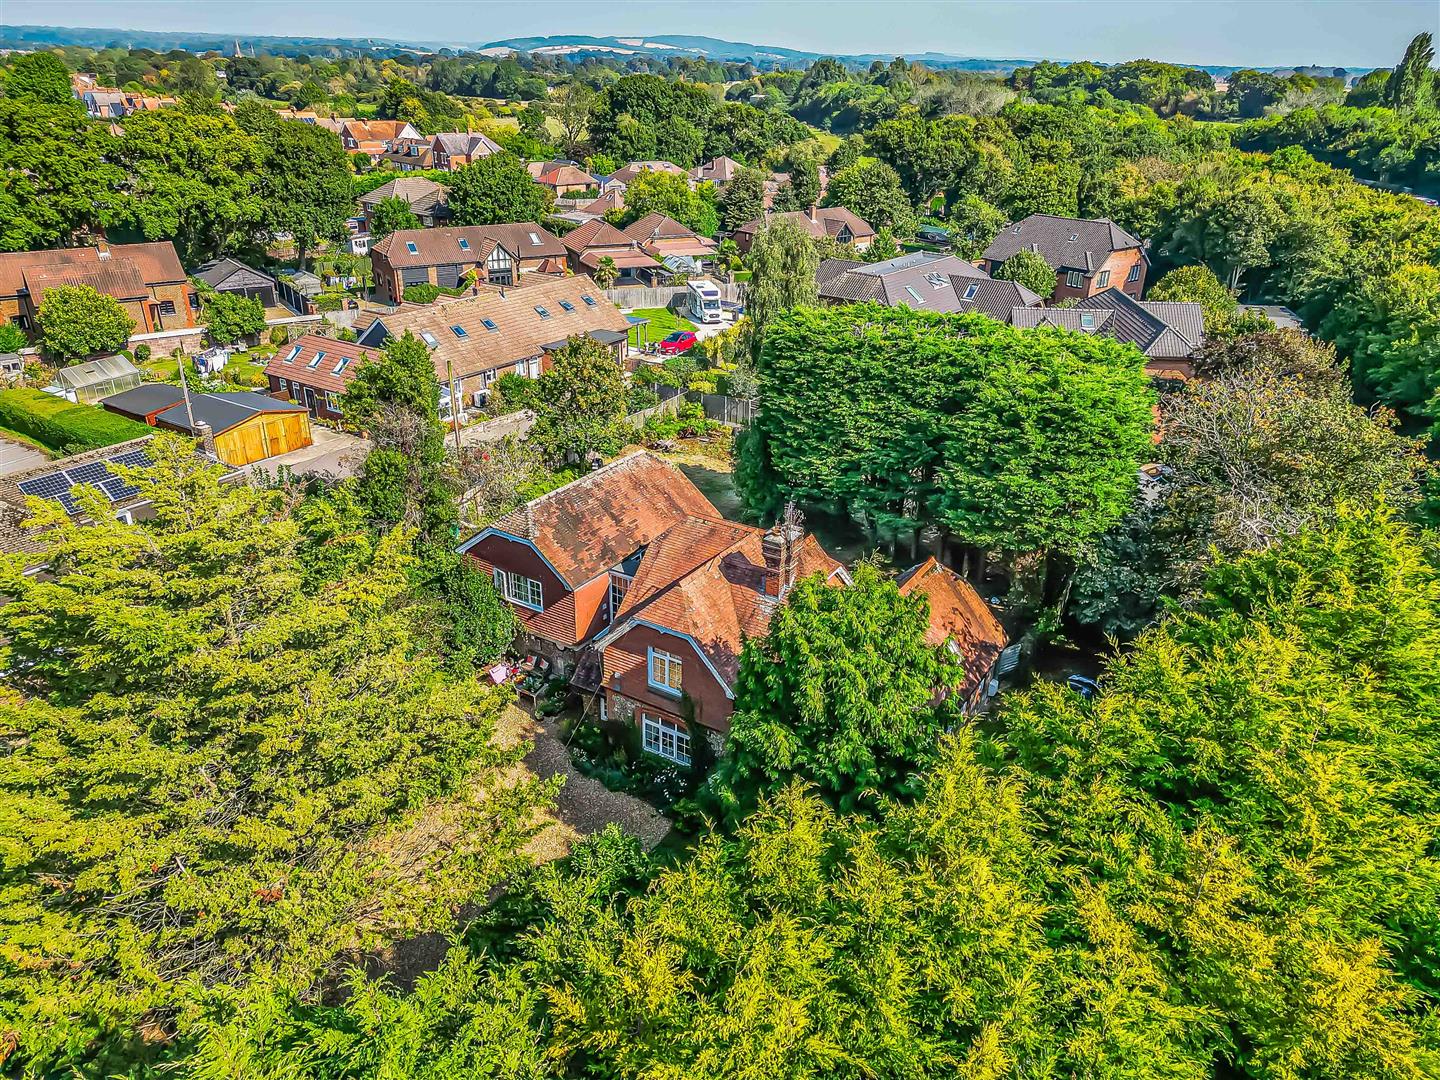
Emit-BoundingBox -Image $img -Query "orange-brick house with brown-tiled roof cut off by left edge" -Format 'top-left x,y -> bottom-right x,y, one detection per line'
0,240 -> 199,342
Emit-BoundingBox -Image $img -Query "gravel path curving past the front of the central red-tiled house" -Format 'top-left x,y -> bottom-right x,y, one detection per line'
501,706 -> 670,850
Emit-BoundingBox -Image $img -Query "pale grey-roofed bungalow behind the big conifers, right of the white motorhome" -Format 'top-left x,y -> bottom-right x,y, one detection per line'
815,251 -> 1041,323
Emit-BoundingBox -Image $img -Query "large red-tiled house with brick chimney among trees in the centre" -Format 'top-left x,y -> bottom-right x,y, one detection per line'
459,452 -> 850,765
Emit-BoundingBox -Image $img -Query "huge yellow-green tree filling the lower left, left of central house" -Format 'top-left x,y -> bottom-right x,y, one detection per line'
0,435 -> 547,1074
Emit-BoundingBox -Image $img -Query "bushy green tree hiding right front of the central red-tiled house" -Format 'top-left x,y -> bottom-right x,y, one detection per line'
710,558 -> 962,818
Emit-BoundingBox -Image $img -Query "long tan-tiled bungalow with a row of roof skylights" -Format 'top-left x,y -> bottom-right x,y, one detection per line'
356,274 -> 629,415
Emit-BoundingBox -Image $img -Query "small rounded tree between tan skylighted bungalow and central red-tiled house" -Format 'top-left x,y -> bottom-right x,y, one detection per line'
530,337 -> 625,465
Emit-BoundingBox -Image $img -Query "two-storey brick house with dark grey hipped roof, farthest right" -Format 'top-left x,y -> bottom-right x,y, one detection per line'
979,213 -> 1149,304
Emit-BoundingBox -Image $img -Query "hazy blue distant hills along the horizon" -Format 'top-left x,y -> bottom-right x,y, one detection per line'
0,24 -> 1368,76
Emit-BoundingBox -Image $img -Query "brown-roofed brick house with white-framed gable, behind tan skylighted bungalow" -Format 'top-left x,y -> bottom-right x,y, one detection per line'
370,222 -> 567,304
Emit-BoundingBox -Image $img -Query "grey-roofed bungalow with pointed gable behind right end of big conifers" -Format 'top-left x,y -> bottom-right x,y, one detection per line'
1009,288 -> 1205,379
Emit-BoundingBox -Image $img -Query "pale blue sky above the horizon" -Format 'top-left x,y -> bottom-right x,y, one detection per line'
0,0 -> 1440,69
